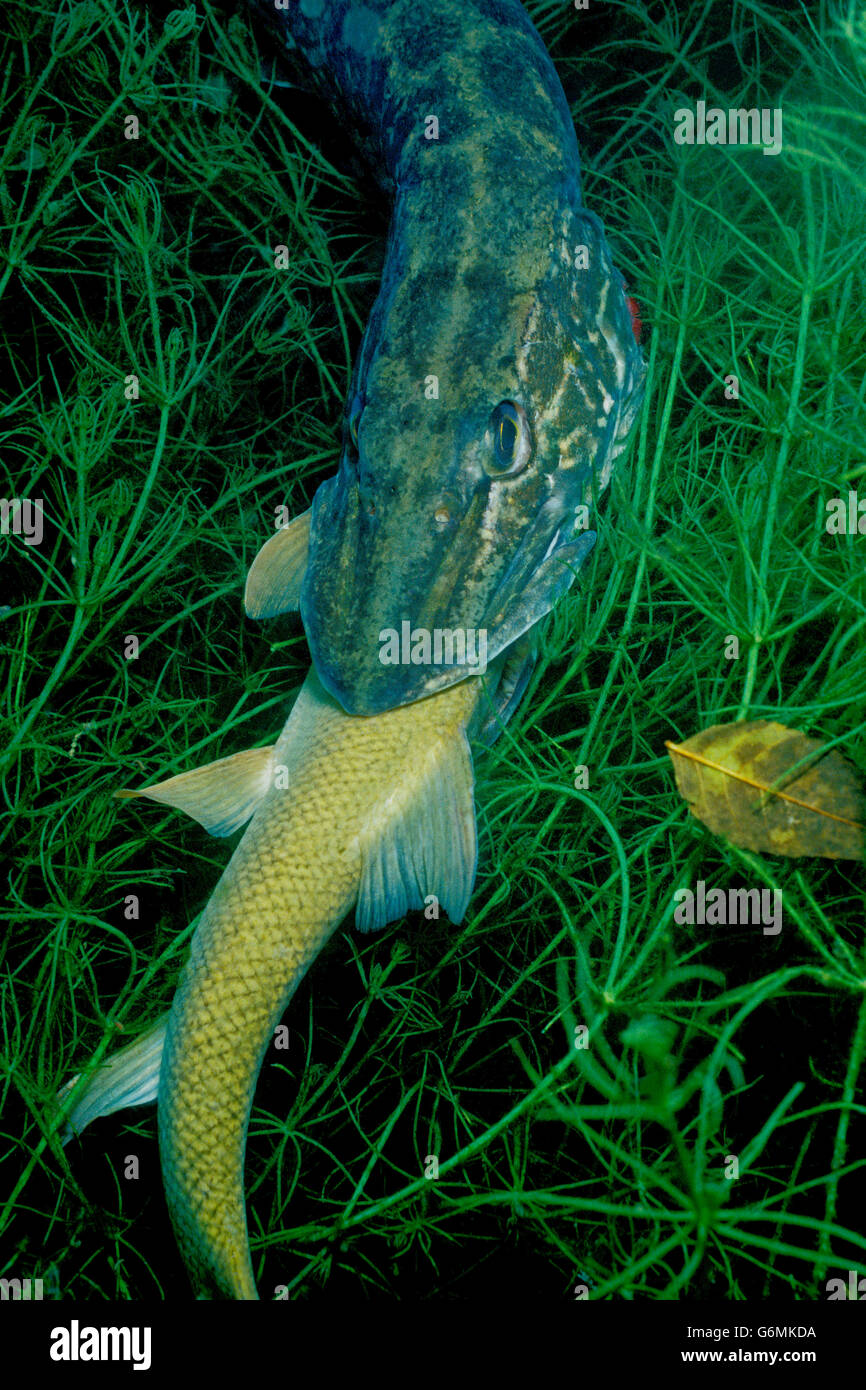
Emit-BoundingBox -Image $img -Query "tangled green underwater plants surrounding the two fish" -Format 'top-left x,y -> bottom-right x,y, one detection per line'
0,0 -> 866,1301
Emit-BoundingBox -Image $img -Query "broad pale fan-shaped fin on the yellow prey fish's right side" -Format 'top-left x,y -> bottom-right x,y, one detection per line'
354,731 -> 478,931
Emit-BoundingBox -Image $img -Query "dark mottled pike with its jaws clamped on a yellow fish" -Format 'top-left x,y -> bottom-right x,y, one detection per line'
256,0 -> 644,714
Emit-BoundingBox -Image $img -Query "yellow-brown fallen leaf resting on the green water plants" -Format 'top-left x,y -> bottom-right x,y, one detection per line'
664,719 -> 866,859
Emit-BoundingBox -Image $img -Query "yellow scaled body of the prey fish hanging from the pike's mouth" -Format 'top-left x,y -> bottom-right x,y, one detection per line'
158,673 -> 481,1298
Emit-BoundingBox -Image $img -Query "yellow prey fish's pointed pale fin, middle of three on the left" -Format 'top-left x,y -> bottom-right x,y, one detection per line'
114,745 -> 274,835
